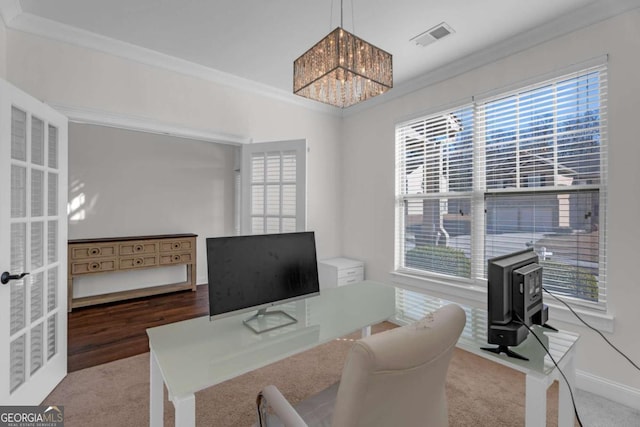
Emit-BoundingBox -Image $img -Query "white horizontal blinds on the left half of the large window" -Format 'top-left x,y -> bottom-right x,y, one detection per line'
396,105 -> 473,278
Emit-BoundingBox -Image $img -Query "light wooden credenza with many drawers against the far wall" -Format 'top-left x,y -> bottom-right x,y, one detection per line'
67,234 -> 197,311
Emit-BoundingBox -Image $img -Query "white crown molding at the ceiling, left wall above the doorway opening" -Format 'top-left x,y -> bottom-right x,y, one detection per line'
0,9 -> 341,116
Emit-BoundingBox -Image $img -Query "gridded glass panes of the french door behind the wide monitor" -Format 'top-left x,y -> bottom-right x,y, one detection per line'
251,151 -> 298,234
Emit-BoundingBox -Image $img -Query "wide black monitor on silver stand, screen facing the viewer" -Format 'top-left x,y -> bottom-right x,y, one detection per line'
206,231 -> 320,333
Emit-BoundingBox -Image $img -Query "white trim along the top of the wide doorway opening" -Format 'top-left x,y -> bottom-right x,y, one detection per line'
49,103 -> 252,145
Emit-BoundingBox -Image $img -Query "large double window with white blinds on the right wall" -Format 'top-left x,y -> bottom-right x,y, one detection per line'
396,65 -> 607,306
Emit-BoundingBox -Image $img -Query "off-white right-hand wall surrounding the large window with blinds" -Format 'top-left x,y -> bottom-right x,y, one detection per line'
342,10 -> 640,407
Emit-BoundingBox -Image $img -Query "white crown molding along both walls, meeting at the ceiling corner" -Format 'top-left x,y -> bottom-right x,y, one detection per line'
5,0 -> 640,117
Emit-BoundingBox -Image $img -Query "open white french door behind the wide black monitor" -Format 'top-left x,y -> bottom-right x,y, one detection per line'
240,140 -> 307,234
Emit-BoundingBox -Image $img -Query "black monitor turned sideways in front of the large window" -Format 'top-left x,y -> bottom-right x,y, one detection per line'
483,249 -> 548,359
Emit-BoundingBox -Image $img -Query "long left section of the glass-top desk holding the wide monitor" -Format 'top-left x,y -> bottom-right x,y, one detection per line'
147,281 -> 395,427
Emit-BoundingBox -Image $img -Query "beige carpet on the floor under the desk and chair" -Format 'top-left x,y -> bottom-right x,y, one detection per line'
43,324 -> 557,427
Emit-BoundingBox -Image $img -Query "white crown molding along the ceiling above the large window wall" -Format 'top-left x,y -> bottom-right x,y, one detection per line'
344,0 -> 640,117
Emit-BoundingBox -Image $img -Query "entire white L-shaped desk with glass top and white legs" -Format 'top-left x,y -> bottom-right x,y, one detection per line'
147,281 -> 579,427
